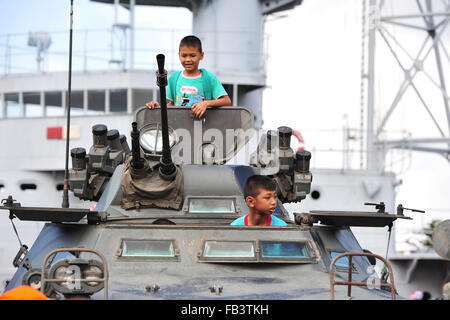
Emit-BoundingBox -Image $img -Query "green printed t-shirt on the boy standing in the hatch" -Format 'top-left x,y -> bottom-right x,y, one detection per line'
167,69 -> 228,107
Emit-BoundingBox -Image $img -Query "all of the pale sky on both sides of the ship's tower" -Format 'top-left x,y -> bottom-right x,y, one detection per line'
0,0 -> 450,232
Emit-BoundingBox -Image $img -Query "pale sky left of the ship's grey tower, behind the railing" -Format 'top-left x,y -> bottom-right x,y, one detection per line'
0,0 -> 192,72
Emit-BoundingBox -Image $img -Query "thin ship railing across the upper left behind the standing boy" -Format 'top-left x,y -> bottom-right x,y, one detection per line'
0,26 -> 269,75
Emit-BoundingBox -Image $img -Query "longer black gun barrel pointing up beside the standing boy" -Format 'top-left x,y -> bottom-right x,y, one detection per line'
156,54 -> 176,180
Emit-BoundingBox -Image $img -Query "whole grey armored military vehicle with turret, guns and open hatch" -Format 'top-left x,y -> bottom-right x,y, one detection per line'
1,55 -> 422,299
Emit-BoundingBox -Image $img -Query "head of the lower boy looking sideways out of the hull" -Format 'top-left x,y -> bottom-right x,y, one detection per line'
244,175 -> 277,215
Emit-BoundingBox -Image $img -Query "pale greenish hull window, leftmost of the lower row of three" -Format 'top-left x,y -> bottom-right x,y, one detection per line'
120,240 -> 177,258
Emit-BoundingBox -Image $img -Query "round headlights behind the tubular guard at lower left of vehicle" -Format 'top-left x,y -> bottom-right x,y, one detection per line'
48,259 -> 104,295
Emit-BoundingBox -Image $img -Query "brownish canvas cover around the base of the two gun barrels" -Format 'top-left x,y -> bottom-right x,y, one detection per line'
121,155 -> 183,210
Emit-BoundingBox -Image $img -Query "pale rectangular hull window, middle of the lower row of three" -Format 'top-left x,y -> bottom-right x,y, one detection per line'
202,241 -> 256,259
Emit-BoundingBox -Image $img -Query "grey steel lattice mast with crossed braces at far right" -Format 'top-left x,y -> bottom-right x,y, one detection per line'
367,0 -> 450,162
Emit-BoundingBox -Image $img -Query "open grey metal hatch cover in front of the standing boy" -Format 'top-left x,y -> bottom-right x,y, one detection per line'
135,106 -> 254,164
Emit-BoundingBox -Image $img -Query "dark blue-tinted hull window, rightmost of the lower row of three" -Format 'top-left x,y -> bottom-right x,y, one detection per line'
261,241 -> 310,259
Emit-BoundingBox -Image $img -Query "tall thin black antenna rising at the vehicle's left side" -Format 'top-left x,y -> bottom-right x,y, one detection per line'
61,0 -> 73,208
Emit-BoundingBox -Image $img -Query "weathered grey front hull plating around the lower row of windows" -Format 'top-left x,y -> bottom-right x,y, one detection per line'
4,219 -> 398,299
